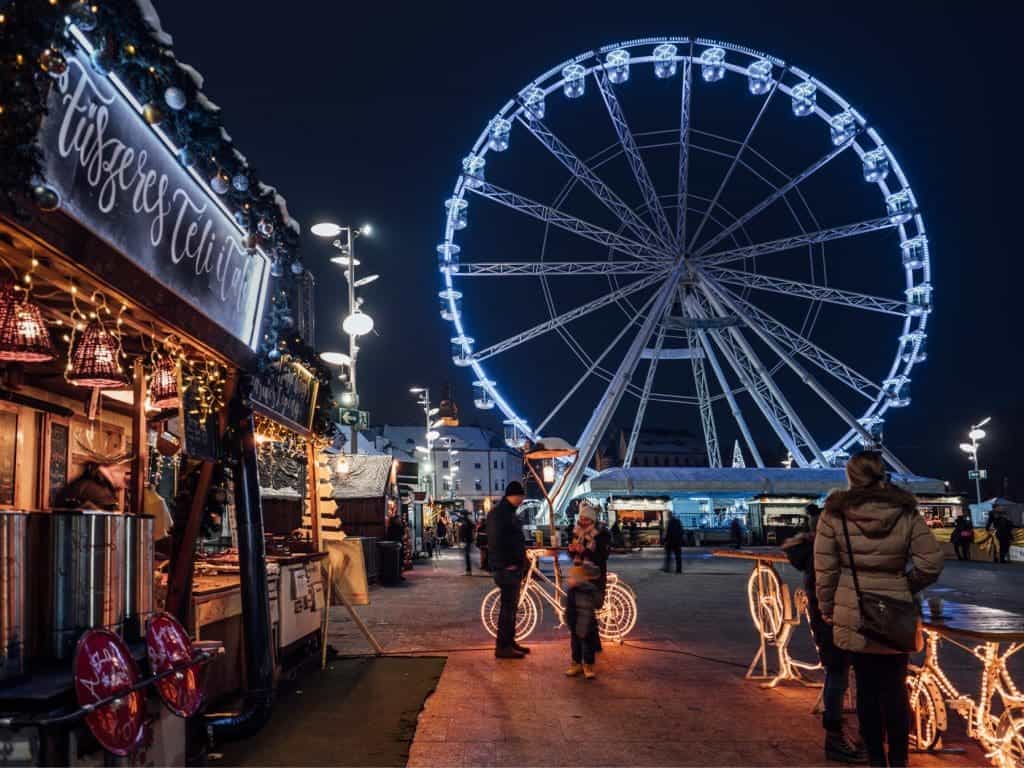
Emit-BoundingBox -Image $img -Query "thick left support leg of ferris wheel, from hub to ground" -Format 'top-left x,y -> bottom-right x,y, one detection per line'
555,259 -> 683,513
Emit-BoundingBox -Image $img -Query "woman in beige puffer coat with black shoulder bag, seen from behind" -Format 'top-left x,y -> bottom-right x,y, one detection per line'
814,451 -> 943,766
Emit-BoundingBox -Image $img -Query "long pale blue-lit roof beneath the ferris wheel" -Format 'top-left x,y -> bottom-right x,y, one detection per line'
575,467 -> 945,497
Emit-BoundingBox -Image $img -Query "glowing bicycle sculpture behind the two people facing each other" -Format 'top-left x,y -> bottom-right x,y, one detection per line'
480,548 -> 637,643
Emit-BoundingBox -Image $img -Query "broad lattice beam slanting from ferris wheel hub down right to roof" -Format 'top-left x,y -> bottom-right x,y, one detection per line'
698,284 -> 825,467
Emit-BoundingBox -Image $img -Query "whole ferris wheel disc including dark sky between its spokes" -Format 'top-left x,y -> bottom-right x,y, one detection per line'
436,38 -> 932,507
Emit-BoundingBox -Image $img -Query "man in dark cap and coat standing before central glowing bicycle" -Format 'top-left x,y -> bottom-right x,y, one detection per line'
487,480 -> 529,658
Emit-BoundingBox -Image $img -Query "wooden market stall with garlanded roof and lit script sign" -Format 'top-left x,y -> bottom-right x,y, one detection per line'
0,0 -> 335,765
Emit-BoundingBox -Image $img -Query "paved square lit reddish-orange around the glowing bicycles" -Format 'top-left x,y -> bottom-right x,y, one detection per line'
331,550 -> 1024,766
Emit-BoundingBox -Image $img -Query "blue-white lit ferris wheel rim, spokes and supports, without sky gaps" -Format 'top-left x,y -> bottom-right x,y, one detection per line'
437,38 -> 932,518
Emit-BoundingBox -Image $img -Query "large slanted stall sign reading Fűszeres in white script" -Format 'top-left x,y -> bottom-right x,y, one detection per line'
39,49 -> 269,349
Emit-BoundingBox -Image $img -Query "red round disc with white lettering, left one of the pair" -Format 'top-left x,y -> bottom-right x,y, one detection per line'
75,630 -> 145,757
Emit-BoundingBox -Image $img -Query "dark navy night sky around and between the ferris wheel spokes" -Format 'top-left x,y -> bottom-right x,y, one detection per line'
157,0 -> 1024,497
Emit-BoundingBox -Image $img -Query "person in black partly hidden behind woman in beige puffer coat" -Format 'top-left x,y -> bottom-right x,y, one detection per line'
782,504 -> 867,763
